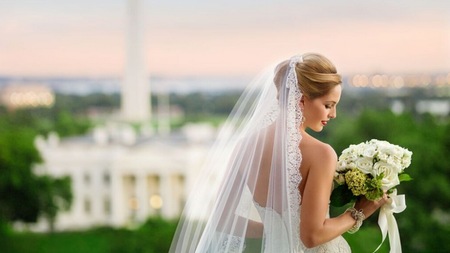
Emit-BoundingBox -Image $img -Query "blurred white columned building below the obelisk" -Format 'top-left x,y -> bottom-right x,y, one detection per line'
31,123 -> 215,231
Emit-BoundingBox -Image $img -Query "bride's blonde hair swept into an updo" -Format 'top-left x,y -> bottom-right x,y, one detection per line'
295,53 -> 342,100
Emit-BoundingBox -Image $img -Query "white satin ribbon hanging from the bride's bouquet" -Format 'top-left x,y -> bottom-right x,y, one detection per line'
374,190 -> 406,253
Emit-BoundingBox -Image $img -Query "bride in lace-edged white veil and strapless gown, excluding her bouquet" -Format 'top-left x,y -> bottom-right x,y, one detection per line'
170,53 -> 386,253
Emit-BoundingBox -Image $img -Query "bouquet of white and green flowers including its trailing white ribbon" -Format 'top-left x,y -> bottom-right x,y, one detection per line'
331,139 -> 412,253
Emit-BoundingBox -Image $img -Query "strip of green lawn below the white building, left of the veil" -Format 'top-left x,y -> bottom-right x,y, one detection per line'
0,217 -> 177,253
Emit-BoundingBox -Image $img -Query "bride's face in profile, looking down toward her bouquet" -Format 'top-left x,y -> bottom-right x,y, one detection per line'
300,85 -> 342,132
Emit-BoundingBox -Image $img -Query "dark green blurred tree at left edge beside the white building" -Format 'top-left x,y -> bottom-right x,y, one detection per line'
0,106 -> 72,232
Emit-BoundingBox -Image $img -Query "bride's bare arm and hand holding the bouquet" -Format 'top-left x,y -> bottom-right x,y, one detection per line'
300,145 -> 385,248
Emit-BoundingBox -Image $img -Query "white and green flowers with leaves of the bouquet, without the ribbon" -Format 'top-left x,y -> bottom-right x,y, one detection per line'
331,139 -> 412,206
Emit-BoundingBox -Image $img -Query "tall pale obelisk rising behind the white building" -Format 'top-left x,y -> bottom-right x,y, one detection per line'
121,0 -> 151,122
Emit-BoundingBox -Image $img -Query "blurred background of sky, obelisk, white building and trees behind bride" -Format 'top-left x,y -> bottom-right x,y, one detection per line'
0,0 -> 450,252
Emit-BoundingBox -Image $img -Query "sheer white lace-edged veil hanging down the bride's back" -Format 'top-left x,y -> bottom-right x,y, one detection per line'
170,55 -> 304,253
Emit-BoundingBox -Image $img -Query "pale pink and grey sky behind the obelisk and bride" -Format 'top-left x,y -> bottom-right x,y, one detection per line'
0,0 -> 450,77
